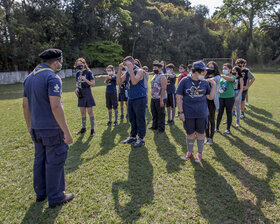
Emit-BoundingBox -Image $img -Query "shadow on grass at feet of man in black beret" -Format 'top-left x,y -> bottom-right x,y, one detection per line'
21,201 -> 62,224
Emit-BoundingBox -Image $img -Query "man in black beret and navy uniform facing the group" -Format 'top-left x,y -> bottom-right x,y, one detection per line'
23,49 -> 74,208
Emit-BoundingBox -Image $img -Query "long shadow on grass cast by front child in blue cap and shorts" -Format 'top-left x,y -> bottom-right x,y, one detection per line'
192,160 -> 244,223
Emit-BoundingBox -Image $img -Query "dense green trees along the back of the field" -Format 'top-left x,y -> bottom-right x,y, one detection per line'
0,0 -> 280,71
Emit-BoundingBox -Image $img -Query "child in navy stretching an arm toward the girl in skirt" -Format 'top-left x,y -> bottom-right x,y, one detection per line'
96,65 -> 118,126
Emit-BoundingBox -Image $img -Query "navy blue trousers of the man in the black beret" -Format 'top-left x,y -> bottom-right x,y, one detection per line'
31,129 -> 68,204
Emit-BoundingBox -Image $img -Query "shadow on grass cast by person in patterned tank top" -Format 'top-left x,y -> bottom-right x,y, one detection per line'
154,132 -> 184,173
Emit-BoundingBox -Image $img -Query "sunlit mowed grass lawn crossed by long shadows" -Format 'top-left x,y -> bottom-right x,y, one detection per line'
0,73 -> 280,224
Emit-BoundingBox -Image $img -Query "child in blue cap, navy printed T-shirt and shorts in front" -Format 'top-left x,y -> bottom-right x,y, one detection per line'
176,61 -> 216,162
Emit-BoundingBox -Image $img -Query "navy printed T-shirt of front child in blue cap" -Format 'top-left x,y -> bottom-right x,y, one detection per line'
176,77 -> 211,118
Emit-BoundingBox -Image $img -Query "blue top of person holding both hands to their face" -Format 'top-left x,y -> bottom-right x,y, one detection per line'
126,66 -> 147,100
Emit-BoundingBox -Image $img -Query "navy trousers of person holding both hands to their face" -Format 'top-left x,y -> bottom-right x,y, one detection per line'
127,97 -> 147,139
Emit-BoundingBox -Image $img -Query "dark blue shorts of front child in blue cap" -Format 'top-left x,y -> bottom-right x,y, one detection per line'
184,117 -> 208,135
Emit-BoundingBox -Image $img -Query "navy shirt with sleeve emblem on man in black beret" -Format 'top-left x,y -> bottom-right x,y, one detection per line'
23,64 -> 62,129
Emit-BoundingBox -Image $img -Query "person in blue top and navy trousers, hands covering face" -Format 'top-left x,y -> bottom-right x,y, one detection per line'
117,56 -> 147,147
